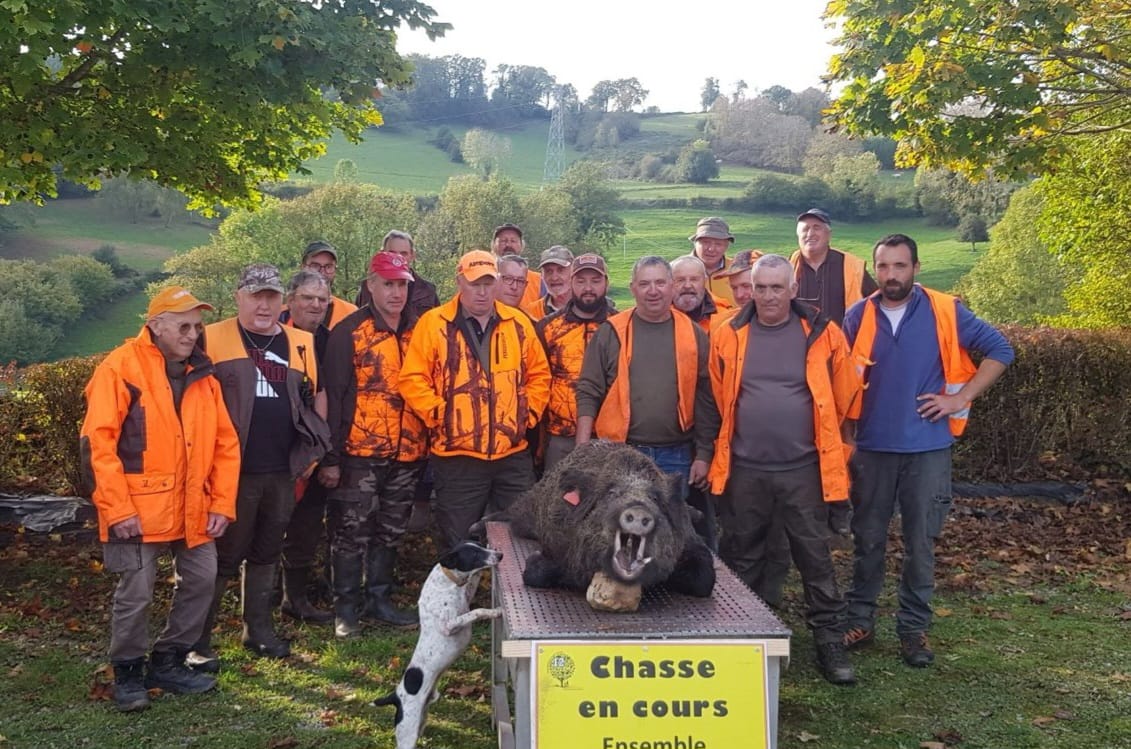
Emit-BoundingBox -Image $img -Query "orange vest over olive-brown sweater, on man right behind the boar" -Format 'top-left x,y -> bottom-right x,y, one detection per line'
594,310 -> 699,442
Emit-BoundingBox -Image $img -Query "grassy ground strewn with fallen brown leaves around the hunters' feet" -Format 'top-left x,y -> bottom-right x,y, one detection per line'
0,497 -> 1131,749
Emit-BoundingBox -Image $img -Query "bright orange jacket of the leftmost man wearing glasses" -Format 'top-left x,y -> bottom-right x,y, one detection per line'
80,327 -> 240,548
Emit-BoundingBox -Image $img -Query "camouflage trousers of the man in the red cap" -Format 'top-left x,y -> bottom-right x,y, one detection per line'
327,456 -> 424,557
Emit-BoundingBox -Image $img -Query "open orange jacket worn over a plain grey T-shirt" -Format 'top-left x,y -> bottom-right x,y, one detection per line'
707,307 -> 860,502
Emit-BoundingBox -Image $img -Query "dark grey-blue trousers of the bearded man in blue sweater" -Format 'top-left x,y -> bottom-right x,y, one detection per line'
846,448 -> 951,635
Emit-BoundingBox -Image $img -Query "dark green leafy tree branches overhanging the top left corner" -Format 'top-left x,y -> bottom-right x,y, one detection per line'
0,0 -> 449,207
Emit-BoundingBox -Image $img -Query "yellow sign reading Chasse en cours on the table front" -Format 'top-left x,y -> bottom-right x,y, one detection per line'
530,640 -> 769,749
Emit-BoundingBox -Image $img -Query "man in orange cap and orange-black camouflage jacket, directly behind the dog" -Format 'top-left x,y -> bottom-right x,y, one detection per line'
399,250 -> 550,549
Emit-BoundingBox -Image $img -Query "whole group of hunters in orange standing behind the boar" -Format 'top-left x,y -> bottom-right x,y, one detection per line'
81,208 -> 1013,711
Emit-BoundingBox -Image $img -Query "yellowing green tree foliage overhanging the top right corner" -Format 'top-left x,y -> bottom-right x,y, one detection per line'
826,0 -> 1131,177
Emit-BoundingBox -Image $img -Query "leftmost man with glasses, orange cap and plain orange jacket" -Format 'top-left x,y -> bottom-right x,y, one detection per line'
81,286 -> 240,712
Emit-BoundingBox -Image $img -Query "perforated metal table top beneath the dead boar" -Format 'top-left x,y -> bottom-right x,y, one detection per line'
487,523 -> 791,639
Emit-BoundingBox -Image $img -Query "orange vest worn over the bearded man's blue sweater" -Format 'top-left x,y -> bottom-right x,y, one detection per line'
851,284 -> 978,437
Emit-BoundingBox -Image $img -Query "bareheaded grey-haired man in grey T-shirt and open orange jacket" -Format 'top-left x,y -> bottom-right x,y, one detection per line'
708,255 -> 860,683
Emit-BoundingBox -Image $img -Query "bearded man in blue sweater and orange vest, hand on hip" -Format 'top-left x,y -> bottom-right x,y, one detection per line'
844,234 -> 1013,668
